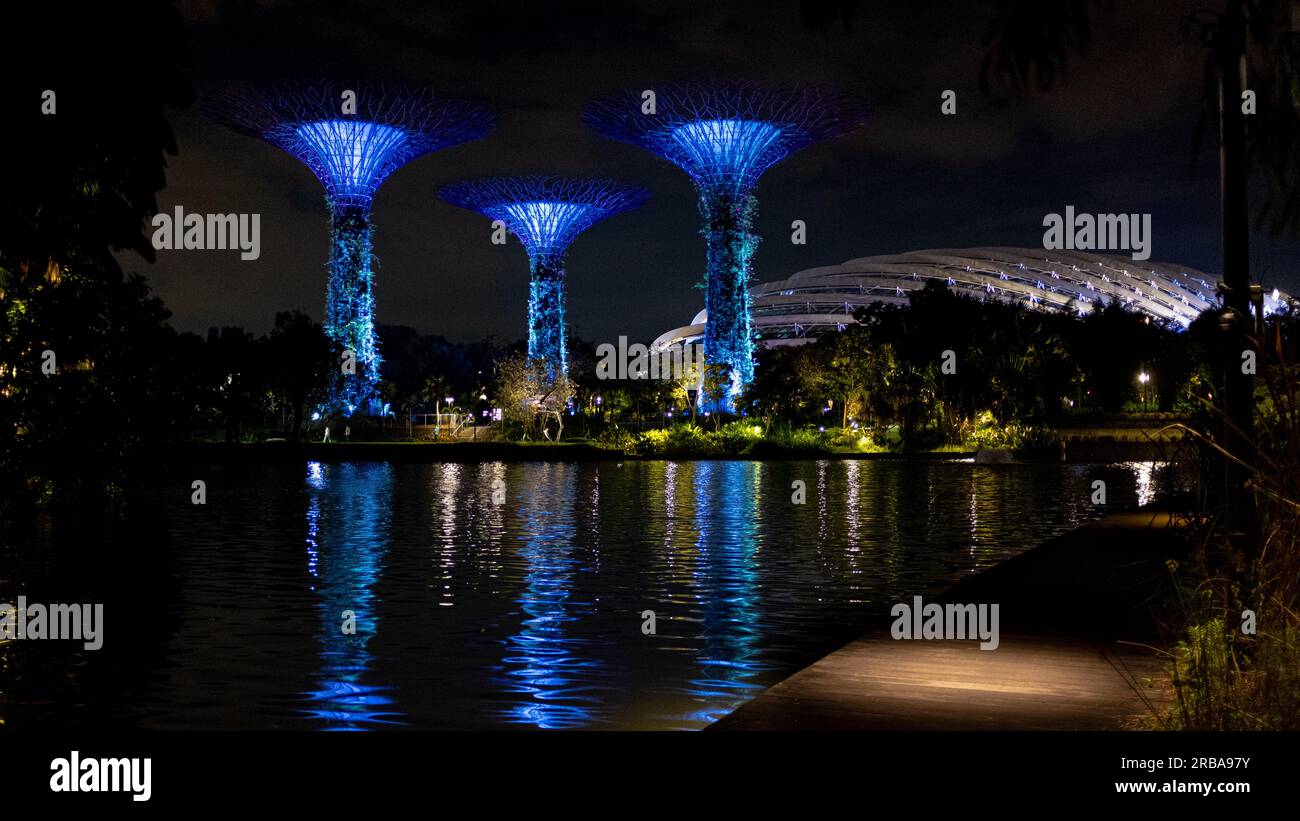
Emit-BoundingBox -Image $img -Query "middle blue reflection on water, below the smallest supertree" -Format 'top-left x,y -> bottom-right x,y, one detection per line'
502,464 -> 601,729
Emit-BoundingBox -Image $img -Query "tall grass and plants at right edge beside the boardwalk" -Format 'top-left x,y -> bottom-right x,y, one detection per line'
1158,327 -> 1300,730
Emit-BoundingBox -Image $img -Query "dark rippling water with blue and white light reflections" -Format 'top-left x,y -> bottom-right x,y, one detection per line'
0,461 -> 1165,730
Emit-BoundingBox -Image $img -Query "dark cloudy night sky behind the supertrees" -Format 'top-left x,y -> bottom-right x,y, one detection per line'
121,0 -> 1300,342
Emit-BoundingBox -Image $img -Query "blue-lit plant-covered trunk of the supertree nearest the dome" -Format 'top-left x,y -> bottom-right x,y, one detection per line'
699,192 -> 758,412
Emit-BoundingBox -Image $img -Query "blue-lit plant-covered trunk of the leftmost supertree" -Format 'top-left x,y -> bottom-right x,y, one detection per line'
325,207 -> 380,416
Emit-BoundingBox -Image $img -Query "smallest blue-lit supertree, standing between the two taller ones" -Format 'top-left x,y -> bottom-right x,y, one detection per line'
438,177 -> 650,381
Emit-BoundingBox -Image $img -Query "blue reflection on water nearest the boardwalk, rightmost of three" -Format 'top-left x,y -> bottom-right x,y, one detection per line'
688,461 -> 768,724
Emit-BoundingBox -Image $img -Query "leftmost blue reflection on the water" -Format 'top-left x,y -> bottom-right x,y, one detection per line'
304,462 -> 403,730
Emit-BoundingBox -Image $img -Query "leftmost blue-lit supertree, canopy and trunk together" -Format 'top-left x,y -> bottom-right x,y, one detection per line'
204,82 -> 493,416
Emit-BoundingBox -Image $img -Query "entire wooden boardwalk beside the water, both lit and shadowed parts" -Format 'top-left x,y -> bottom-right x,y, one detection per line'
709,511 -> 1186,730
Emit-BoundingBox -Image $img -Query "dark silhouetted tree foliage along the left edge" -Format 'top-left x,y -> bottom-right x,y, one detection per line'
0,0 -> 194,518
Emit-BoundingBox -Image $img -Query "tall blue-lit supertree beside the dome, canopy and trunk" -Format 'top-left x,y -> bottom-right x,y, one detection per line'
584,83 -> 867,411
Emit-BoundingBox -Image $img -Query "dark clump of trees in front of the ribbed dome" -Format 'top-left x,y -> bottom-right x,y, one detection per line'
741,283 -> 1185,449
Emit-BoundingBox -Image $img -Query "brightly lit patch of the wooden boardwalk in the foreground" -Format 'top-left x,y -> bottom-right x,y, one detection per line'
710,631 -> 1170,730
